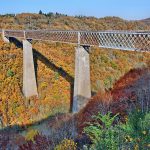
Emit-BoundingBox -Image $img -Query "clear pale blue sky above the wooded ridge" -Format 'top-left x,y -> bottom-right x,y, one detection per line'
0,0 -> 150,20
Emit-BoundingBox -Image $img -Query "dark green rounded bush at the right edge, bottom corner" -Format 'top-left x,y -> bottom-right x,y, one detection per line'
120,110 -> 150,149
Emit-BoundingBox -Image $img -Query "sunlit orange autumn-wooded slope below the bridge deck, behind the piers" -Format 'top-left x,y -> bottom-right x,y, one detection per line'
0,36 -> 150,127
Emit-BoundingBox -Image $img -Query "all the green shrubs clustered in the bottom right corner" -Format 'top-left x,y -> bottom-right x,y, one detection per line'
84,110 -> 150,150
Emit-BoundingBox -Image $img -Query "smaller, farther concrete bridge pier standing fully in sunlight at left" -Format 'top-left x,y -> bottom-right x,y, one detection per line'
23,40 -> 38,97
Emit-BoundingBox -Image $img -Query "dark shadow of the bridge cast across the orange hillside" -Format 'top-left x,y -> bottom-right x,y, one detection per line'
9,37 -> 74,112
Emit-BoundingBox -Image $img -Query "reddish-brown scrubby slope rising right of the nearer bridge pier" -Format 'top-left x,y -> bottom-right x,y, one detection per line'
78,67 -> 150,131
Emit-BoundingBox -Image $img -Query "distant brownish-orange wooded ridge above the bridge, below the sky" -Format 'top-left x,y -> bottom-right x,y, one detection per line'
0,13 -> 150,31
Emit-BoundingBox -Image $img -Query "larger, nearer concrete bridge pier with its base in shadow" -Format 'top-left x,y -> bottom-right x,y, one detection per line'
72,47 -> 91,113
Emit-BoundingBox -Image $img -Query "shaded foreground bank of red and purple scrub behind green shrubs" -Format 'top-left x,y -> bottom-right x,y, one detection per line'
0,55 -> 150,150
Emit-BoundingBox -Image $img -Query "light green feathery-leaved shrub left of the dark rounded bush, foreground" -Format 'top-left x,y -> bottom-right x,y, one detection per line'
84,112 -> 119,150
